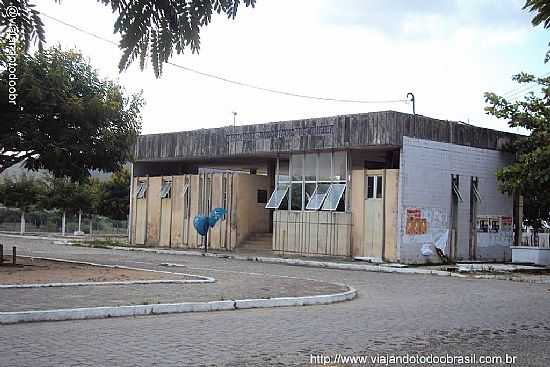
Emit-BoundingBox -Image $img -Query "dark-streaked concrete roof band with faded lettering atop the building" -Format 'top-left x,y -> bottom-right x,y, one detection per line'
135,111 -> 519,162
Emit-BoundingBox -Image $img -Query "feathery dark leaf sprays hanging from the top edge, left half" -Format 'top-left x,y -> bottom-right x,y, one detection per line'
0,0 -> 256,77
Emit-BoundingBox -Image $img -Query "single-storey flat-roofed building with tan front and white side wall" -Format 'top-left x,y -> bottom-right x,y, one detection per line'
130,111 -> 520,264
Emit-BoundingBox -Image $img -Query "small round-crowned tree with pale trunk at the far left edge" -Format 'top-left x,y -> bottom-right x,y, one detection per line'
0,176 -> 44,234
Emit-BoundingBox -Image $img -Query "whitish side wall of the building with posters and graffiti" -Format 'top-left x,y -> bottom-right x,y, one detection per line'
398,137 -> 513,263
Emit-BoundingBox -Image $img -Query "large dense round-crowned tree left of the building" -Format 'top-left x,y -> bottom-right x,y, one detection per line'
0,47 -> 143,181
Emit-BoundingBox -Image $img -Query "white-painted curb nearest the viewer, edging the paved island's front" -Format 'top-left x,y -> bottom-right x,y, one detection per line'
0,287 -> 357,324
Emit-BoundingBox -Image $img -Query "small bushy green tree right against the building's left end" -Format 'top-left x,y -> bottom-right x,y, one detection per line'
98,167 -> 131,220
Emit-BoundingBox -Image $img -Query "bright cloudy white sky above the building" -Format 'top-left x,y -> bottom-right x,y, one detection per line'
35,0 -> 550,134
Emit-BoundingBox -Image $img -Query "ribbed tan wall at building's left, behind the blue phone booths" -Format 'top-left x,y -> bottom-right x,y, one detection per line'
131,173 -> 243,250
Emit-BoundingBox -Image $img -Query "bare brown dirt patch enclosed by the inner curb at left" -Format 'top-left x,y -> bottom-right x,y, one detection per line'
0,256 -> 189,284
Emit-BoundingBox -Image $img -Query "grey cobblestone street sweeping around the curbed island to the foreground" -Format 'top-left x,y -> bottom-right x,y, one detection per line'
0,238 -> 550,367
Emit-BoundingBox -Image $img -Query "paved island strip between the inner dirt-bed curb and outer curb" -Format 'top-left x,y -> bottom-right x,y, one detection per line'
0,239 -> 348,312
